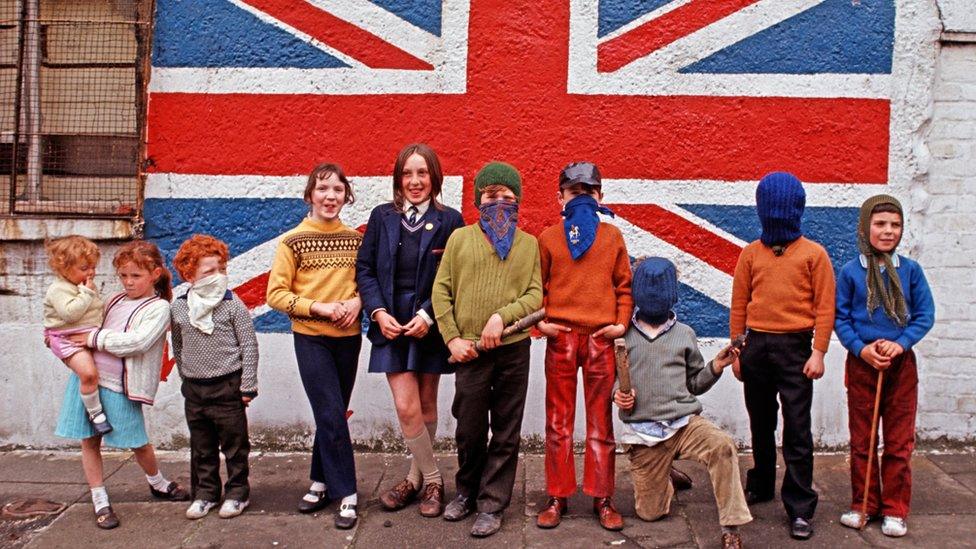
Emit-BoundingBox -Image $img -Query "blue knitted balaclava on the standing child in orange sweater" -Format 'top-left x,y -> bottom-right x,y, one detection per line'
756,172 -> 807,246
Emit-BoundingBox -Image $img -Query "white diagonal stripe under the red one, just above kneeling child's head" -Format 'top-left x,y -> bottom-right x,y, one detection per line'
608,216 -> 732,307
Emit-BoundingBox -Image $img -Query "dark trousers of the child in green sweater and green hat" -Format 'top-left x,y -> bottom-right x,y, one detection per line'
451,339 -> 530,513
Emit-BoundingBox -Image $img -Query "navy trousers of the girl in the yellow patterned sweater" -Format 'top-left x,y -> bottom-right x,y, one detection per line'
295,333 -> 363,499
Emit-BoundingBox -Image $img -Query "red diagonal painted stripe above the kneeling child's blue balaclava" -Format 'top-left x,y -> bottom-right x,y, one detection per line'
608,204 -> 742,275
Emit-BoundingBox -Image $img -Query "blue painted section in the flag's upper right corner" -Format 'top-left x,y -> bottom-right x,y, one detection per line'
679,0 -> 895,74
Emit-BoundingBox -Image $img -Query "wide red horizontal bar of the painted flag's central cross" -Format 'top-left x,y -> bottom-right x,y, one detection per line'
149,90 -> 890,185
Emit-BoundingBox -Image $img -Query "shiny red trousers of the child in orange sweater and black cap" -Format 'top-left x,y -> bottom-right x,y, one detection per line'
546,330 -> 616,497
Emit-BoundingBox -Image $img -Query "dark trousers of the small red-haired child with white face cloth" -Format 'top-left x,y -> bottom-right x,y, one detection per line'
180,371 -> 251,501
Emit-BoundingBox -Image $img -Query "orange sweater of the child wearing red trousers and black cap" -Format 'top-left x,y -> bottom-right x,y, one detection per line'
539,222 -> 634,331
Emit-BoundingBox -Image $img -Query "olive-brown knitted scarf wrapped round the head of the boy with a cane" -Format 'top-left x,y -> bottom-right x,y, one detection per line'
857,194 -> 908,326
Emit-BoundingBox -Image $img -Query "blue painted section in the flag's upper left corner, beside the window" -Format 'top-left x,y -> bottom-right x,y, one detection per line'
153,0 -> 348,69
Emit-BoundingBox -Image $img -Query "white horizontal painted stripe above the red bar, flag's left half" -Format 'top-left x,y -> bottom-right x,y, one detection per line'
149,67 -> 466,95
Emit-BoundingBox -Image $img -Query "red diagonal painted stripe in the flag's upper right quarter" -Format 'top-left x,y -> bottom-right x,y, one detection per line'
596,0 -> 759,72
